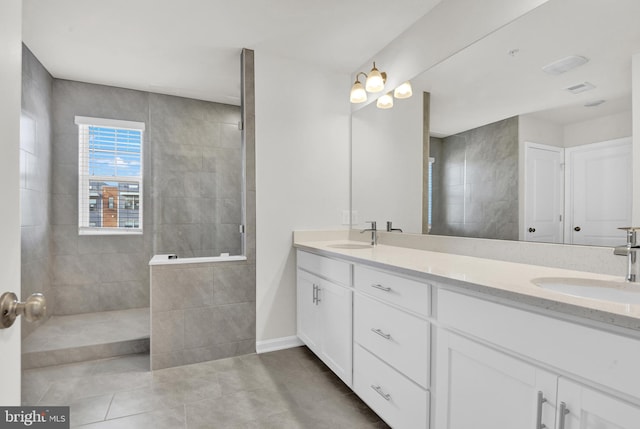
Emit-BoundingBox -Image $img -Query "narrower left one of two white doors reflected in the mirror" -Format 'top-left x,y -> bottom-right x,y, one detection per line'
522,143 -> 564,243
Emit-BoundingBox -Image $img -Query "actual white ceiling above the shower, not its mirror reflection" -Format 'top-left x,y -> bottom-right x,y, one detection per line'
23,0 -> 440,105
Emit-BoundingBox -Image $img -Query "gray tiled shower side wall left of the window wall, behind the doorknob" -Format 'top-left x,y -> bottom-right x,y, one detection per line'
16,45 -> 55,338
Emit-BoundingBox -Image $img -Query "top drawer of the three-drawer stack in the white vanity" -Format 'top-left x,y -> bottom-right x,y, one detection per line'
353,265 -> 431,316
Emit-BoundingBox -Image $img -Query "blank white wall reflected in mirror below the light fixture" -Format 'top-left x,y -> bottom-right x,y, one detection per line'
351,93 -> 423,234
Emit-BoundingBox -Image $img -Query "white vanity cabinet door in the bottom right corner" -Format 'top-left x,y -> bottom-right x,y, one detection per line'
556,378 -> 640,429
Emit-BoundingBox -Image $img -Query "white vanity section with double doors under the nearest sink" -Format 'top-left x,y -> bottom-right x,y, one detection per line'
435,290 -> 640,429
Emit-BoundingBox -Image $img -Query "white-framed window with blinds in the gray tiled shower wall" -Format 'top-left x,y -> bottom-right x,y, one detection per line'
75,116 -> 145,234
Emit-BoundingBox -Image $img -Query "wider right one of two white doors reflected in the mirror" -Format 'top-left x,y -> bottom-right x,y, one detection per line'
565,137 -> 632,246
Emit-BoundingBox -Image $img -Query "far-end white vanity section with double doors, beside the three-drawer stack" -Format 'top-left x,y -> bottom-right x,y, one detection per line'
297,247 -> 353,386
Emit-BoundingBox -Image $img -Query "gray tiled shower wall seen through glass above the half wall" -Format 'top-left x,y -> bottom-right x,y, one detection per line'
148,94 -> 243,258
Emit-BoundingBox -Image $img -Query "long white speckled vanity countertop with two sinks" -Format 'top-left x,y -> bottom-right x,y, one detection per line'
294,240 -> 640,330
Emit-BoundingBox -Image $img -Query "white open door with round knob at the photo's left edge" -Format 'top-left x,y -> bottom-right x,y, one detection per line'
0,0 -> 22,406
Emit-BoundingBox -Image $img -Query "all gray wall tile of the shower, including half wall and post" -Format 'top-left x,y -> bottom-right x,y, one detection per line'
26,46 -> 255,368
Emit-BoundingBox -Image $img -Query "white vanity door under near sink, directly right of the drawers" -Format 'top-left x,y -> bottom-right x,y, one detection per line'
435,329 -> 557,429
